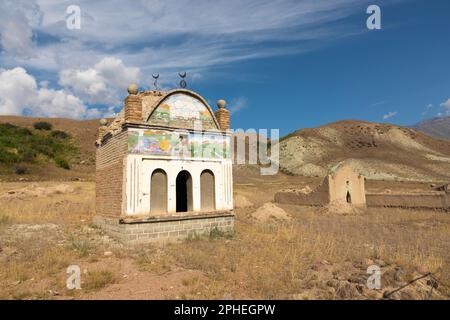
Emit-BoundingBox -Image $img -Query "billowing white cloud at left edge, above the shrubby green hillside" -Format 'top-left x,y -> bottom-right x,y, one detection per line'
0,67 -> 101,118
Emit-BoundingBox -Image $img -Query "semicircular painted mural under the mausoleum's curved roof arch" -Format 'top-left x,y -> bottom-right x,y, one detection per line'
148,93 -> 217,129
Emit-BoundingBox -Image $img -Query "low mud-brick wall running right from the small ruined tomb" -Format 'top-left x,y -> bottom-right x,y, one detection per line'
366,192 -> 450,209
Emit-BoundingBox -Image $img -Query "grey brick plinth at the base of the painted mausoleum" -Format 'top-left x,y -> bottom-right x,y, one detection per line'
93,211 -> 234,243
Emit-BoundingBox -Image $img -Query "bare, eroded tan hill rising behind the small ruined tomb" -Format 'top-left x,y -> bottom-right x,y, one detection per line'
280,120 -> 450,181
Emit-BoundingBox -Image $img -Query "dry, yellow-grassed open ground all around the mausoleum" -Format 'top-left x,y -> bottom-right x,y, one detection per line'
0,178 -> 450,299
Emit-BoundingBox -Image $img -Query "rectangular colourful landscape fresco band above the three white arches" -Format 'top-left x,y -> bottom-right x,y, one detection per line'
128,130 -> 231,159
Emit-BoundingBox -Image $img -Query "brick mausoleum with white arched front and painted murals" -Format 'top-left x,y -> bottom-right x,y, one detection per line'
94,85 -> 234,242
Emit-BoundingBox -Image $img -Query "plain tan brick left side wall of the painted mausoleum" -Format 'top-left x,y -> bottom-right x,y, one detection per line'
95,131 -> 128,216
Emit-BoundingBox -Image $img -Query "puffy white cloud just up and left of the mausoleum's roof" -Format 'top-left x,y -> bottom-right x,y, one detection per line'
59,57 -> 139,105
